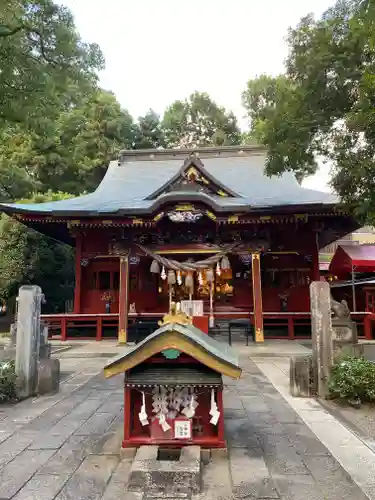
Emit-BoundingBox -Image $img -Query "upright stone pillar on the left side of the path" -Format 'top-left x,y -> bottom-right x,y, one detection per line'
16,285 -> 43,398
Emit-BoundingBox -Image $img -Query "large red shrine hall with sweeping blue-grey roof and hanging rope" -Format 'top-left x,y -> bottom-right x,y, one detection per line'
1,146 -> 357,342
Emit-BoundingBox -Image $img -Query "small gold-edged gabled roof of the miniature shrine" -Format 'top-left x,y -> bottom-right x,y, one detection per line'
104,320 -> 241,378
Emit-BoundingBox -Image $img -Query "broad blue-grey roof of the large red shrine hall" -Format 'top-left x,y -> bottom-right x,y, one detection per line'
0,146 -> 338,217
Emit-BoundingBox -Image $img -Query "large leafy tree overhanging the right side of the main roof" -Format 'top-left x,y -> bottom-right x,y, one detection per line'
243,0 -> 375,222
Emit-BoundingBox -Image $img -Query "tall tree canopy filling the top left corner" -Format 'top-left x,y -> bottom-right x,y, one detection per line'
0,0 -> 104,125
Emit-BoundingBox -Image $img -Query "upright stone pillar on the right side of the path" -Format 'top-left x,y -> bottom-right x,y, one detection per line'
310,281 -> 333,398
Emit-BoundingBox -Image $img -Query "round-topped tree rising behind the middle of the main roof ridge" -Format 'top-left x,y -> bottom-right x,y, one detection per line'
162,92 -> 241,147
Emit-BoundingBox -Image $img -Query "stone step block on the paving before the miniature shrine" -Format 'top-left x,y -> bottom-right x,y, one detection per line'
128,446 -> 201,499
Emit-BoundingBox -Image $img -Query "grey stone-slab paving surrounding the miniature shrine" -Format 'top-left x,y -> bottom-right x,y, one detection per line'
0,356 -> 367,500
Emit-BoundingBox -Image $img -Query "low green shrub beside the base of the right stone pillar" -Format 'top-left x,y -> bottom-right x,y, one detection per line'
328,356 -> 375,402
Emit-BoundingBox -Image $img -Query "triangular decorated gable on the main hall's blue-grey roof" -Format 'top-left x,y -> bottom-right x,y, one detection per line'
146,153 -> 239,200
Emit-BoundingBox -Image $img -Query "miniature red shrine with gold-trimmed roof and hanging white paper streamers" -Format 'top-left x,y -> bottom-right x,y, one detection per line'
104,304 -> 241,448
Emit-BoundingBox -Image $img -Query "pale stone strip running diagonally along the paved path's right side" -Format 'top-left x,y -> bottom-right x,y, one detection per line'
256,358 -> 375,500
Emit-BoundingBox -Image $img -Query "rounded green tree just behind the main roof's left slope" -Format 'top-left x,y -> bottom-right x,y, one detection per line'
40,90 -> 136,194
